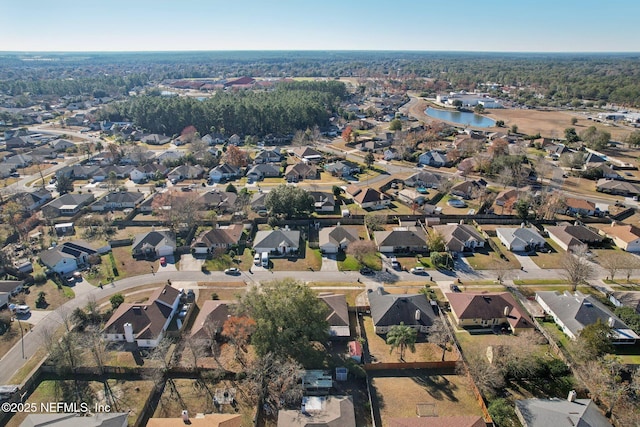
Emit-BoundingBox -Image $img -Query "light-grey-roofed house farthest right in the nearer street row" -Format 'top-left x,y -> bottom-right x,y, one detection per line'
536,291 -> 640,345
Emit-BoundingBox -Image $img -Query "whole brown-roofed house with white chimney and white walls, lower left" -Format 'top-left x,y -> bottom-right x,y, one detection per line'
102,285 -> 181,348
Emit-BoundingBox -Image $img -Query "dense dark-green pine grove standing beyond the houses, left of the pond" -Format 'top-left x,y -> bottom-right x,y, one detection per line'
98,81 -> 347,136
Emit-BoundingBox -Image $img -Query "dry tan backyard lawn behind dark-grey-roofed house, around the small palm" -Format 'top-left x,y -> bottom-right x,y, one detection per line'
362,316 -> 458,362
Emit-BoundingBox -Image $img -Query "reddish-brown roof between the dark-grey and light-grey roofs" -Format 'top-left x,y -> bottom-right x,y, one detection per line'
445,292 -> 533,329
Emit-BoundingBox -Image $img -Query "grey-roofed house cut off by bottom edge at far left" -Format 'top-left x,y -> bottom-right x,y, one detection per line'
20,412 -> 129,427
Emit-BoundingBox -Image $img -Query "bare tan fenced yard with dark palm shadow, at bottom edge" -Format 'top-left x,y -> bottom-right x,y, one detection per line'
371,370 -> 482,427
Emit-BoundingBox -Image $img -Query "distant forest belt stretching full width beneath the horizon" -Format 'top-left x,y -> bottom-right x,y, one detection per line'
0,51 -> 640,107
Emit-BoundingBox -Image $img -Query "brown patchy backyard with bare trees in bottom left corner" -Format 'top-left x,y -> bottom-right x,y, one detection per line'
7,380 -> 153,427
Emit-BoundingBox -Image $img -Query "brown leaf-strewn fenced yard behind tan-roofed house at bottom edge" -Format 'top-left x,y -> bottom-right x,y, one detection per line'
153,379 -> 255,426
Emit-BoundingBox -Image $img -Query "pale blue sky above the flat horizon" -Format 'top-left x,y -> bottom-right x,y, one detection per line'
0,0 -> 640,52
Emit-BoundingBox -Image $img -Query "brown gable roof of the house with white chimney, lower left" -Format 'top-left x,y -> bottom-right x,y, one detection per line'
104,285 -> 180,340
